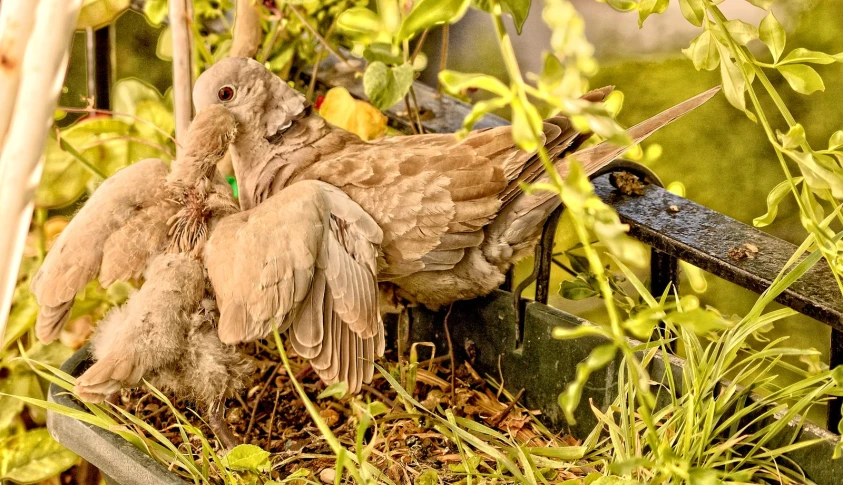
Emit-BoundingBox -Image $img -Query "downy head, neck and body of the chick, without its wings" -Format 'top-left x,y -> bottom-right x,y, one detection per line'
74,108 -> 250,448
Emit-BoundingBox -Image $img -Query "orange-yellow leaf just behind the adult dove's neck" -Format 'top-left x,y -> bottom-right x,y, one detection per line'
319,87 -> 386,141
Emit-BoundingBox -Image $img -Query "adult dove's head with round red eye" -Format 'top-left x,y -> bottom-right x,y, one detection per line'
193,57 -> 308,142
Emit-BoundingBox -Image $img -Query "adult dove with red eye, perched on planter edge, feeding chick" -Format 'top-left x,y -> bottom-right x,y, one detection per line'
193,58 -> 719,318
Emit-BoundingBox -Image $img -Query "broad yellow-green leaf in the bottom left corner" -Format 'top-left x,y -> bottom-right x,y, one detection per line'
0,428 -> 77,483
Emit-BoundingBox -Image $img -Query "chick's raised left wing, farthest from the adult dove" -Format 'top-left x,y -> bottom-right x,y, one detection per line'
32,159 -> 173,342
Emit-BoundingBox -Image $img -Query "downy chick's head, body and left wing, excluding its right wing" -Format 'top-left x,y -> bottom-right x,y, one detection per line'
32,106 -> 250,448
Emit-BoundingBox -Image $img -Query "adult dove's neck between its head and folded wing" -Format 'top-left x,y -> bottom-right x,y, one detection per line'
231,113 -> 359,210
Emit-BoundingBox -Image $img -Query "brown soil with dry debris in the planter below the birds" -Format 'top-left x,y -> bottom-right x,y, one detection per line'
115,344 -> 583,483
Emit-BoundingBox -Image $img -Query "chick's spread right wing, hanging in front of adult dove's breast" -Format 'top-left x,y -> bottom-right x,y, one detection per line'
204,181 -> 384,391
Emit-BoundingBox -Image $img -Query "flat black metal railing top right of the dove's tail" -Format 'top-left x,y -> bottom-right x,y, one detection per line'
594,176 -> 843,330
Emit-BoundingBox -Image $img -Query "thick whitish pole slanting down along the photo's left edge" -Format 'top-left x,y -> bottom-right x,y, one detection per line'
0,0 -> 82,338
